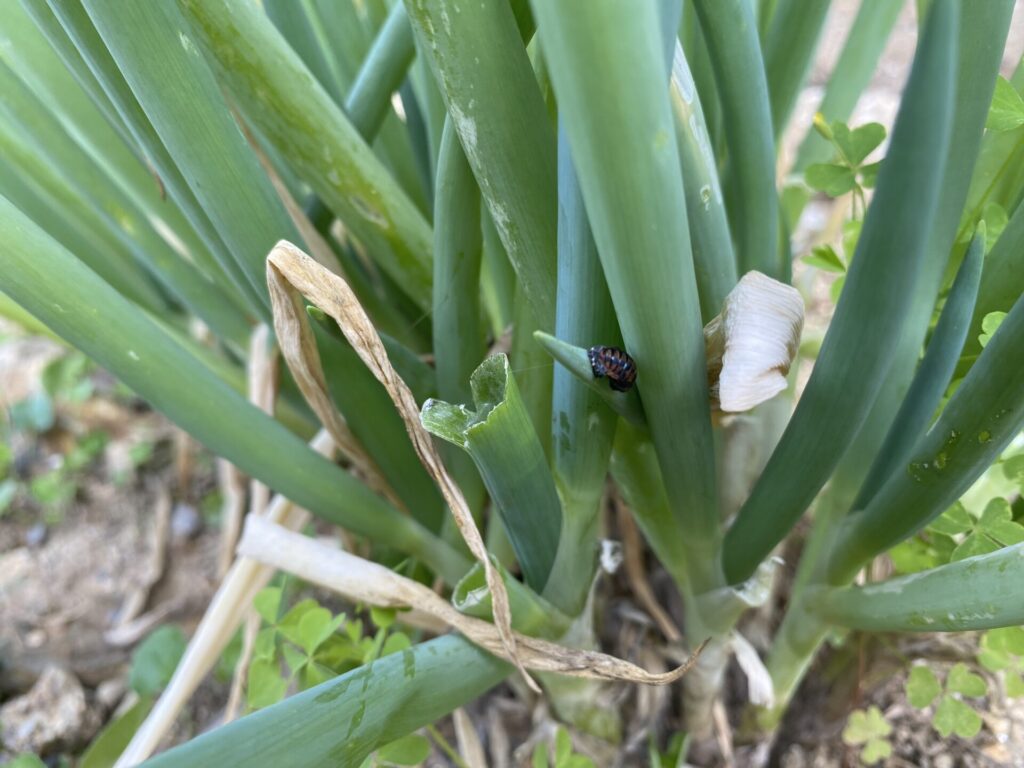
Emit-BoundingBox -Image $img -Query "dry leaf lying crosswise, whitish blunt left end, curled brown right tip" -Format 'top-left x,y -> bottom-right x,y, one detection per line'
239,517 -> 707,685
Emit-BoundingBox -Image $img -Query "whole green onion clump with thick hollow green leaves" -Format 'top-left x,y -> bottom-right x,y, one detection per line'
0,0 -> 1024,767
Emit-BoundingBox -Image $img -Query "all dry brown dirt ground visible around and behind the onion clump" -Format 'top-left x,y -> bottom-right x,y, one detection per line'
0,0 -> 1024,768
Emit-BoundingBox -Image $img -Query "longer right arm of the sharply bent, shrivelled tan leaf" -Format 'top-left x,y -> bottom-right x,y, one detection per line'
267,240 -> 540,691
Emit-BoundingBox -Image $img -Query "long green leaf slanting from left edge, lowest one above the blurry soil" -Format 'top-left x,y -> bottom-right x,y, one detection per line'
0,198 -> 469,583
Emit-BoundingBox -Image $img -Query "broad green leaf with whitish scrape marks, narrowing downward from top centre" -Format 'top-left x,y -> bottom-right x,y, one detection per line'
406,0 -> 558,331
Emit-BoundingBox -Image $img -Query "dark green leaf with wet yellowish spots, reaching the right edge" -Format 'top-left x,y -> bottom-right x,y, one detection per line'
828,288 -> 1024,584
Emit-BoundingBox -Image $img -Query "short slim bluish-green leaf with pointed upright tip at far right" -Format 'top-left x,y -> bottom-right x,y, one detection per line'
853,225 -> 985,510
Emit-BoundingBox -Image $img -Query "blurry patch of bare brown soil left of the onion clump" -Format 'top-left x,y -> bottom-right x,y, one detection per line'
0,328 -> 218,760
